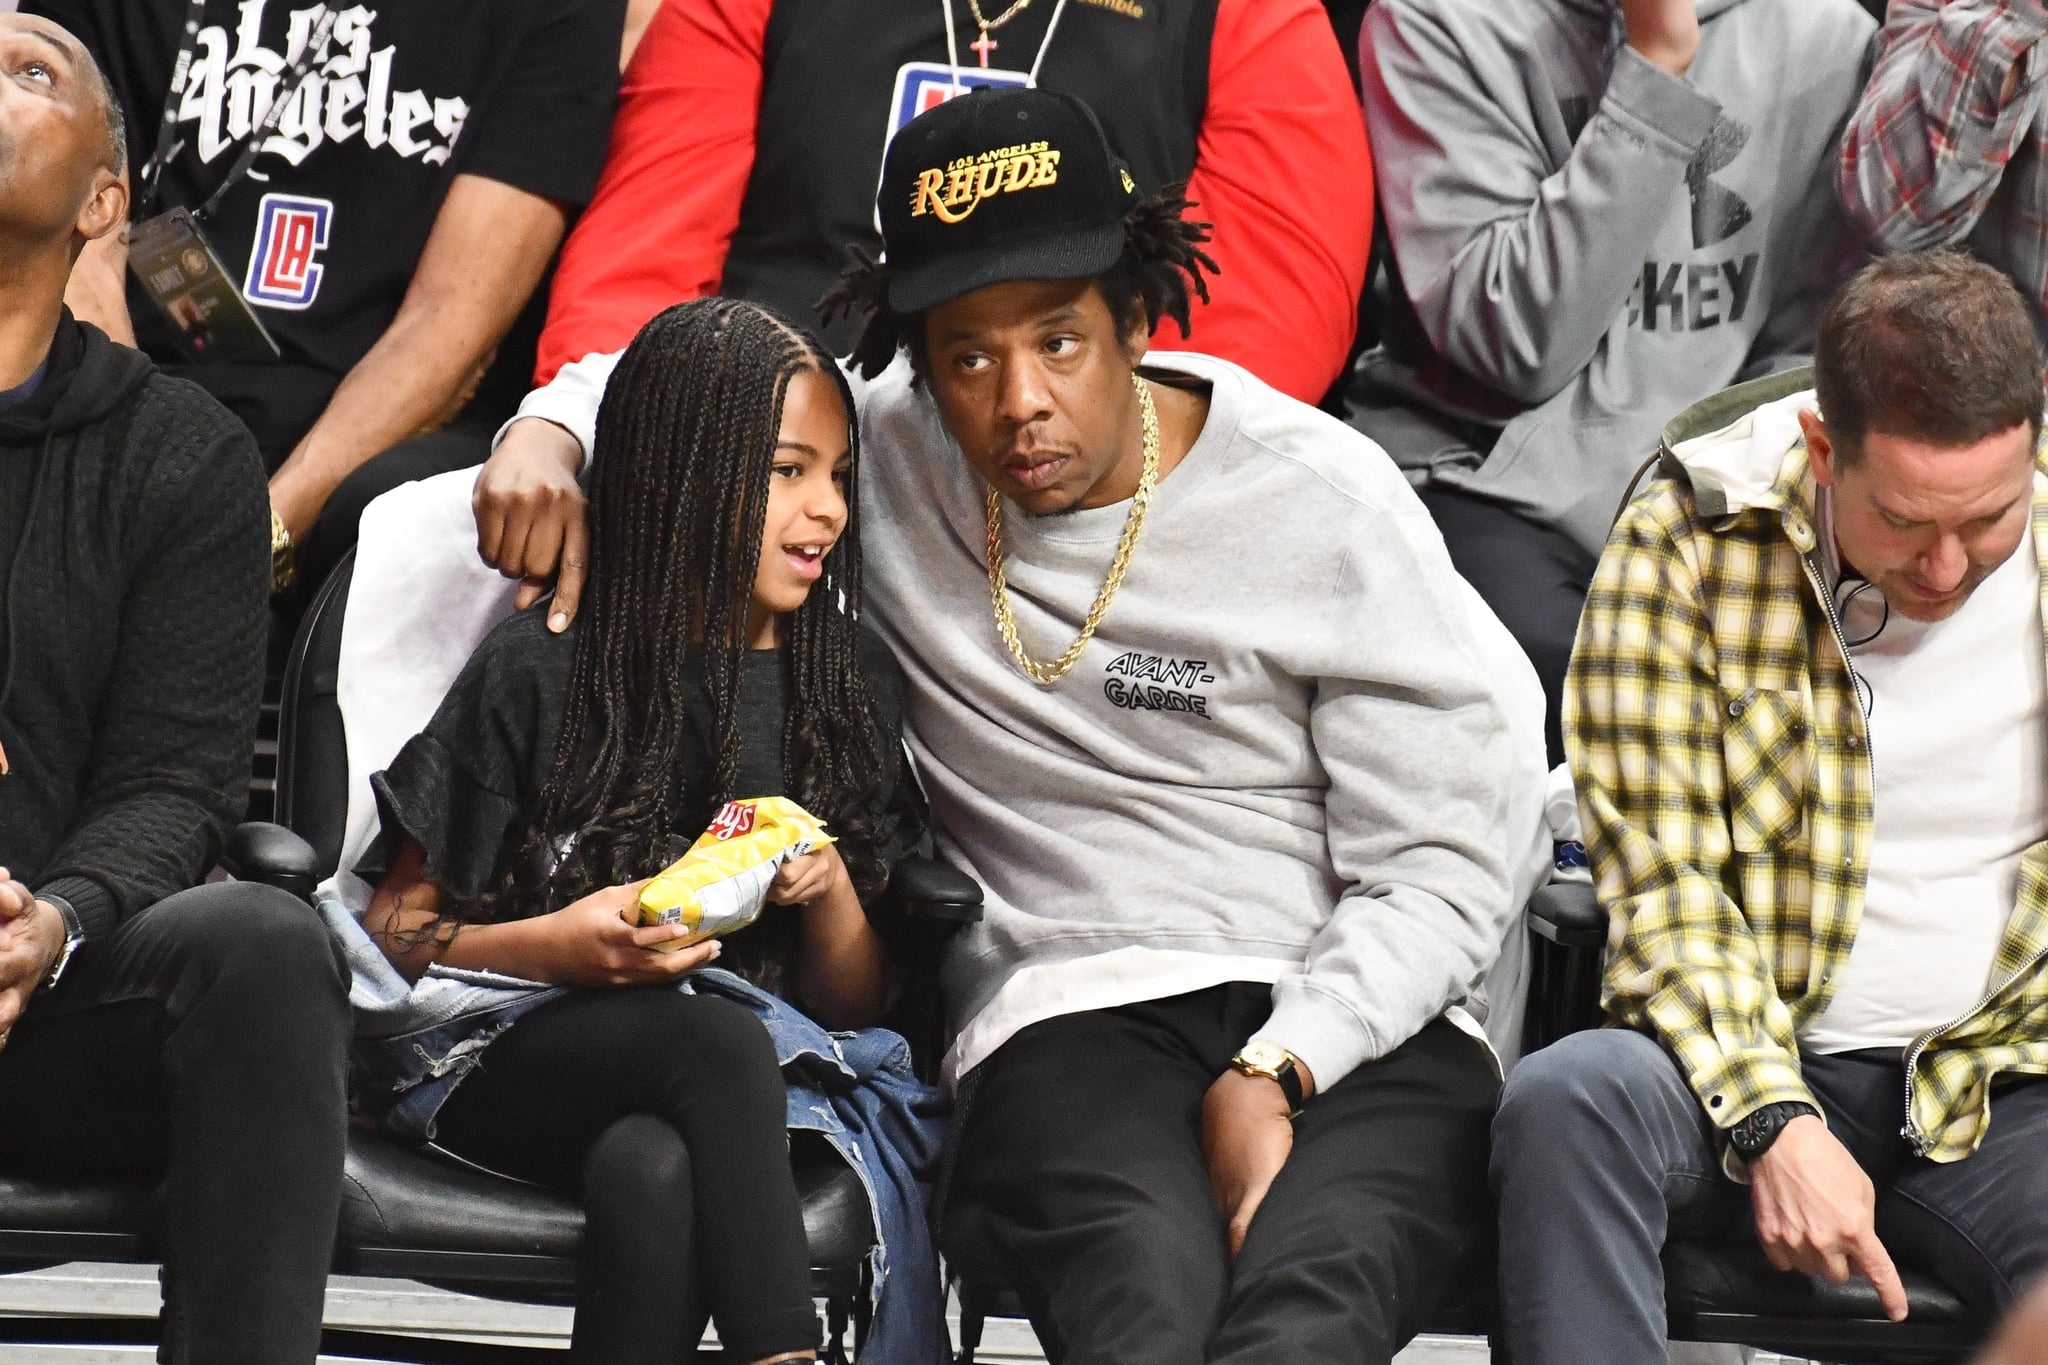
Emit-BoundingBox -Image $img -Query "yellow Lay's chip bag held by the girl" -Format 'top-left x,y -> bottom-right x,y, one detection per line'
639,796 -> 836,952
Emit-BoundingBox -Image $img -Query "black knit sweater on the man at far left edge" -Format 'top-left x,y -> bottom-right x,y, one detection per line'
0,313 -> 270,937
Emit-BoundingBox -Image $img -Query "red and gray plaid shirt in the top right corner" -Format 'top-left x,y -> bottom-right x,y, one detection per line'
1841,0 -> 2048,340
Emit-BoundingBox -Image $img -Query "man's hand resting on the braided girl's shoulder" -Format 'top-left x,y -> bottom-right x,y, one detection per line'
471,417 -> 590,634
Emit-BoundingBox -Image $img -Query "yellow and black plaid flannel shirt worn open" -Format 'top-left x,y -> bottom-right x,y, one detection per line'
1565,394 -> 2048,1160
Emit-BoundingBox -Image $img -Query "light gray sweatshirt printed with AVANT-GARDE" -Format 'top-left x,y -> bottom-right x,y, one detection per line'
520,354 -> 1548,1087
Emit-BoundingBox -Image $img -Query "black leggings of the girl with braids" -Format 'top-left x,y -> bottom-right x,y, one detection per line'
434,988 -> 817,1365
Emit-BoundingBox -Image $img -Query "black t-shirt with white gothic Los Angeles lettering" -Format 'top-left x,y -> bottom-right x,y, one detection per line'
20,0 -> 625,446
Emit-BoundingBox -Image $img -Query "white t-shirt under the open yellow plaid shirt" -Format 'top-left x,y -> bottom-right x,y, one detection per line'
1800,518 -> 2048,1052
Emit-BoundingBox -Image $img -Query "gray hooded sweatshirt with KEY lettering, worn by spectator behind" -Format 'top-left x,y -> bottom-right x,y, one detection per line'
1350,0 -> 1876,551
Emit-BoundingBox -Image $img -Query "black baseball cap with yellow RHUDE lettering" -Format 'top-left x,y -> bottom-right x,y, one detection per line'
879,86 -> 1139,313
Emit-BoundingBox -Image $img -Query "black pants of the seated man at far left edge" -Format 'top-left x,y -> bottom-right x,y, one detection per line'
0,882 -> 350,1365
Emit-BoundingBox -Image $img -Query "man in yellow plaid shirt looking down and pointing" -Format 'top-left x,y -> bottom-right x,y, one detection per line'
1493,252 -> 2048,1365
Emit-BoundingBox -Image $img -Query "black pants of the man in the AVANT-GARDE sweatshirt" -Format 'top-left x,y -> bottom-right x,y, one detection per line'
944,982 -> 1499,1365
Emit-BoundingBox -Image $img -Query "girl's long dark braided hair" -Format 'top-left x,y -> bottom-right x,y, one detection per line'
457,299 -> 897,990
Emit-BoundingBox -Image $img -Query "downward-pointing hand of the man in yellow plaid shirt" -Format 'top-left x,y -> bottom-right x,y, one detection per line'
1749,1113 -> 1907,1322
